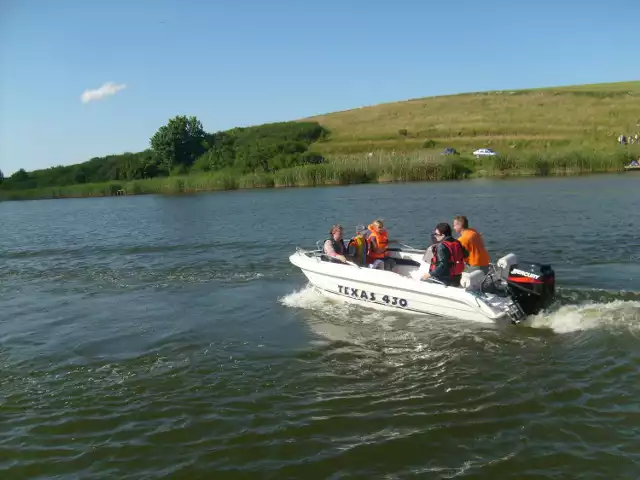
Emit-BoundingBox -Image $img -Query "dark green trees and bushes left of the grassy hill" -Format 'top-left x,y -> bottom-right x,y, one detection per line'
0,115 -> 329,190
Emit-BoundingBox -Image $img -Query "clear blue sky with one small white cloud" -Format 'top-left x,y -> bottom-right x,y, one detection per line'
0,0 -> 640,176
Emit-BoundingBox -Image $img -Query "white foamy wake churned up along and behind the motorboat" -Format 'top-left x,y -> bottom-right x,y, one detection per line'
280,285 -> 640,334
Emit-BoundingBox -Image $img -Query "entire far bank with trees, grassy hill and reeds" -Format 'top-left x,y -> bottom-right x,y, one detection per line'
0,82 -> 640,200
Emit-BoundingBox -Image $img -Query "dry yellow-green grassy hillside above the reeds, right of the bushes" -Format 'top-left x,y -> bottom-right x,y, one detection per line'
305,81 -> 640,154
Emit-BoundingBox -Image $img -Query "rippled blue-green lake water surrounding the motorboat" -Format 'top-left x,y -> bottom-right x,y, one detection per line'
0,174 -> 640,480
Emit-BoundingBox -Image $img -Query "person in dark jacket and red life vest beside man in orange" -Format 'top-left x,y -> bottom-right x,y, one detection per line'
422,223 -> 469,287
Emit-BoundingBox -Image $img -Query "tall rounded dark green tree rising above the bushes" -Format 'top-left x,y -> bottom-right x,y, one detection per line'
150,115 -> 206,170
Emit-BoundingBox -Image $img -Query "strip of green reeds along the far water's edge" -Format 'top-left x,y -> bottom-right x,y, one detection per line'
0,146 -> 640,200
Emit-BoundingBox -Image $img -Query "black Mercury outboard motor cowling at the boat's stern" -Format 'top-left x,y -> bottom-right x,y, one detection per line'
507,263 -> 556,315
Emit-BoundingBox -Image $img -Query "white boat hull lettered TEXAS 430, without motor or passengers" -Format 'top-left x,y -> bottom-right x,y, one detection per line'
289,250 -> 524,323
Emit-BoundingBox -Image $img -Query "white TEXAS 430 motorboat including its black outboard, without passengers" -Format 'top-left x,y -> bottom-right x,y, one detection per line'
289,242 -> 555,324
